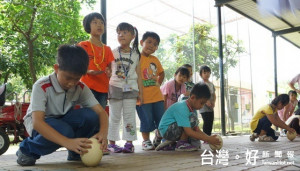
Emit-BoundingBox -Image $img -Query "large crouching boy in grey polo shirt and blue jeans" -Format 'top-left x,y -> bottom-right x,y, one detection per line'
17,45 -> 108,166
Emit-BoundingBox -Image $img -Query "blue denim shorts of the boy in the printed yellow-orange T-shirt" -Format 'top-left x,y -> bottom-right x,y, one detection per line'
136,101 -> 165,132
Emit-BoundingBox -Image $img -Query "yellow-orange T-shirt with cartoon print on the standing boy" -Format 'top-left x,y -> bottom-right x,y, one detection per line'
140,55 -> 164,104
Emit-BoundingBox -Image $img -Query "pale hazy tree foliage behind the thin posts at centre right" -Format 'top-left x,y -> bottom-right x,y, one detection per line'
157,24 -> 245,79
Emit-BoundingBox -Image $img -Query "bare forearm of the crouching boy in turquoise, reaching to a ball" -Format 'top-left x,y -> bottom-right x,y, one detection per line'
183,127 -> 221,145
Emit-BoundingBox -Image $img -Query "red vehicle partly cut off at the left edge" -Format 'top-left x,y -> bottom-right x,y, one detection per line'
0,84 -> 29,155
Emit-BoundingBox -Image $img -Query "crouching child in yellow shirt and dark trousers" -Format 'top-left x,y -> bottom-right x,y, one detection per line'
250,94 -> 295,142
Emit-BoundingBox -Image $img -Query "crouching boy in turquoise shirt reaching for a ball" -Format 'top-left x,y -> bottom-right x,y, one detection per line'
156,83 -> 220,151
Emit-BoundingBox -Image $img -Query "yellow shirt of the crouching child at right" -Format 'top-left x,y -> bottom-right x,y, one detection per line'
250,105 -> 277,132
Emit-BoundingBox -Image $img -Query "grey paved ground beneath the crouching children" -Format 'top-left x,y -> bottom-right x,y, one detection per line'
0,136 -> 300,171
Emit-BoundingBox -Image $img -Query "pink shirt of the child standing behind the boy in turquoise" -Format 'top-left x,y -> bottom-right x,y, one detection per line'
160,79 -> 186,108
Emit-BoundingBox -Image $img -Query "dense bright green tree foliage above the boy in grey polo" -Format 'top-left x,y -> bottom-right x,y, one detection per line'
0,0 -> 95,91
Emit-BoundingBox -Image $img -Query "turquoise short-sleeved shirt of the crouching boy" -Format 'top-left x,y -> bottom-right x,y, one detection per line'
158,100 -> 195,136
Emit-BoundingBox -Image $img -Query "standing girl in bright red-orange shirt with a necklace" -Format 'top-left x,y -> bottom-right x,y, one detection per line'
79,12 -> 114,109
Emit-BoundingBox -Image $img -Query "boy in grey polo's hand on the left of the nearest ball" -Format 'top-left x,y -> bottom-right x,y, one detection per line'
65,138 -> 92,154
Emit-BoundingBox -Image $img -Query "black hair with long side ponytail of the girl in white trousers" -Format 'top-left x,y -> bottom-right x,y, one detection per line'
116,22 -> 141,56
